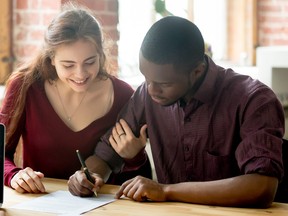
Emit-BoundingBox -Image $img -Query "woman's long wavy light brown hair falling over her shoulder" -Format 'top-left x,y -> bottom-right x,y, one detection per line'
2,3 -> 109,143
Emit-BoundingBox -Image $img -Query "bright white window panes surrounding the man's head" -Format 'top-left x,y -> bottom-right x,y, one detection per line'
118,0 -> 227,87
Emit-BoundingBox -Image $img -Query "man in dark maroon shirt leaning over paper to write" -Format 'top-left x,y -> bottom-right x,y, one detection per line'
68,16 -> 284,208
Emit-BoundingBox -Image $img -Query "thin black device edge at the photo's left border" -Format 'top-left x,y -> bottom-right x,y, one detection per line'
0,123 -> 5,207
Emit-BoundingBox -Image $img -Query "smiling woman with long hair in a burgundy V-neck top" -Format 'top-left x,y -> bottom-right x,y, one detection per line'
0,5 -> 151,193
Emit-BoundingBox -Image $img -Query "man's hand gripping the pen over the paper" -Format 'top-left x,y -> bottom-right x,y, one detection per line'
68,170 -> 104,197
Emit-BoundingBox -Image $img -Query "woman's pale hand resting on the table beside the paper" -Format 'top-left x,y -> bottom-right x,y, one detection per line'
10,167 -> 45,193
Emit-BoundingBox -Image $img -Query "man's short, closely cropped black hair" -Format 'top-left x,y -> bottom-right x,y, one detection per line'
140,16 -> 204,71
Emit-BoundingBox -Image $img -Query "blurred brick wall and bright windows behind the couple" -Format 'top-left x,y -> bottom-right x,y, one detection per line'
0,0 -> 288,137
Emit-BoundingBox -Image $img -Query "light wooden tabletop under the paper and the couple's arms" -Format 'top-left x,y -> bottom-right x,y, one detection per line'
2,178 -> 288,216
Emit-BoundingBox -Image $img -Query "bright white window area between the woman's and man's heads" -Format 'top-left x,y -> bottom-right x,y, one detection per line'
118,0 -> 155,87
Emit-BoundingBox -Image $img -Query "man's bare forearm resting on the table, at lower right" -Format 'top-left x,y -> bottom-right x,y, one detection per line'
164,174 -> 278,208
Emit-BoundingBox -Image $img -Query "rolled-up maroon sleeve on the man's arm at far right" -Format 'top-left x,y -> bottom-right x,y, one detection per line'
236,89 -> 285,180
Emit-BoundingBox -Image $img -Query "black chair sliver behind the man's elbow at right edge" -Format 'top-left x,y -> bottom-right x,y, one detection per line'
274,139 -> 288,203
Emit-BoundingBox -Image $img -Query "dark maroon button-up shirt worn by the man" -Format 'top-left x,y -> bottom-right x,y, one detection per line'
95,58 -> 284,183
